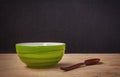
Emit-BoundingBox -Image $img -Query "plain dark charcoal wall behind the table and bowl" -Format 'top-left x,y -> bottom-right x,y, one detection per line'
0,0 -> 120,53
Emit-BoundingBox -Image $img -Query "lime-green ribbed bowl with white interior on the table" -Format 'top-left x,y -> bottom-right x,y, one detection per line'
16,42 -> 65,68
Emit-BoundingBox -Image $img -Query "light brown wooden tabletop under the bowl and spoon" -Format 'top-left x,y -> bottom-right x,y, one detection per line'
0,53 -> 120,77
